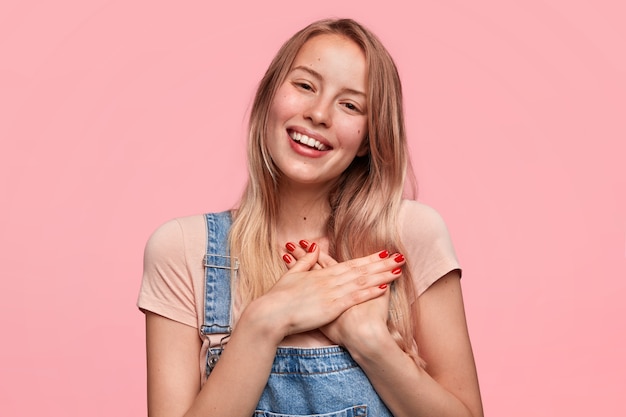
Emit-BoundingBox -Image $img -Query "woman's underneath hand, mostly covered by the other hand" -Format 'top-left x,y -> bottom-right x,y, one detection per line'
283,241 -> 394,351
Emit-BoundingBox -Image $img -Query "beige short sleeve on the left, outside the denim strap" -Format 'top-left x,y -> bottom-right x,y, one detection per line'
137,220 -> 198,327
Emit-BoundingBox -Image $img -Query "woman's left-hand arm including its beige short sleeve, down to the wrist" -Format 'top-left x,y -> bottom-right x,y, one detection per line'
138,216 -> 278,417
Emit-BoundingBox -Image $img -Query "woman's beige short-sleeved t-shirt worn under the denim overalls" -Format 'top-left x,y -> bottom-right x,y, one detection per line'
137,200 -> 460,374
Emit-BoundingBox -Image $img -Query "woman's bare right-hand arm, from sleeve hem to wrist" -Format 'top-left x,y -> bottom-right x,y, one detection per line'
347,271 -> 483,417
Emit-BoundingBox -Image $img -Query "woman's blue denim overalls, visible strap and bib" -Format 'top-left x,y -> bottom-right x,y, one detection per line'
200,212 -> 392,417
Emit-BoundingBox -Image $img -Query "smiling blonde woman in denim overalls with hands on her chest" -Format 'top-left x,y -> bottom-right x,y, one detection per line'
138,19 -> 482,417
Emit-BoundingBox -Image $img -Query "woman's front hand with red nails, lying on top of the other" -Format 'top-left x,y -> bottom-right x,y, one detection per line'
248,244 -> 398,342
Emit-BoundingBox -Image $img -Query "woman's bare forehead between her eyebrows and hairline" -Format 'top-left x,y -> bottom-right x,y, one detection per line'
292,34 -> 367,83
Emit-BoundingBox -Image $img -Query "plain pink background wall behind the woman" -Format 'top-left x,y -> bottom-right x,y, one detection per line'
0,0 -> 626,417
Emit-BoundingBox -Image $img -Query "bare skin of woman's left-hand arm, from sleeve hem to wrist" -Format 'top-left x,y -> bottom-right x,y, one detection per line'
146,309 -> 278,417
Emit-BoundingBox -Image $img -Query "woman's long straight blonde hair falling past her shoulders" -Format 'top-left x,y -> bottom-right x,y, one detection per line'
230,19 -> 417,360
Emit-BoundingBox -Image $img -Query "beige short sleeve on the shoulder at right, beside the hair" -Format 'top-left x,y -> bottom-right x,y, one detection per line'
399,200 -> 461,296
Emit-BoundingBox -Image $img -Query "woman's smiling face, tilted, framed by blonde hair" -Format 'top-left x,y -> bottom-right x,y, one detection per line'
267,34 -> 368,185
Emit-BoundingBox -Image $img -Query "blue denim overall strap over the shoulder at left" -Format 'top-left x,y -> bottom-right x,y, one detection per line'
200,211 -> 239,335
